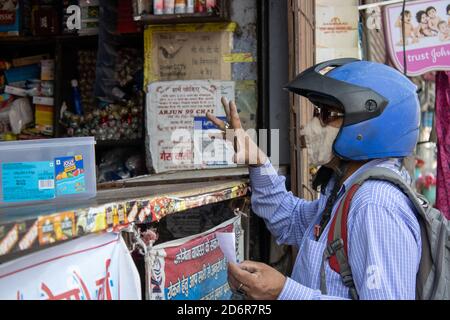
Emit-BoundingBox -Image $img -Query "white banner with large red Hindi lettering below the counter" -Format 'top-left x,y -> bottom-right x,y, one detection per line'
0,233 -> 141,300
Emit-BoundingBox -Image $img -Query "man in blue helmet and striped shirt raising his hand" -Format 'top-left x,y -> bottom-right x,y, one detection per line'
208,59 -> 421,300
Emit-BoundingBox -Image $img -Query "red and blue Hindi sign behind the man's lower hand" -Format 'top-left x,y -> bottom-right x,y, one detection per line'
146,216 -> 244,300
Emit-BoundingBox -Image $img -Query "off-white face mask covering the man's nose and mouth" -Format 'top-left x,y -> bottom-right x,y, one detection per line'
300,117 -> 340,167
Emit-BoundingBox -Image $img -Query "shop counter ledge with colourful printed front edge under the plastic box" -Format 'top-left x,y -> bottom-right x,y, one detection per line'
0,179 -> 249,262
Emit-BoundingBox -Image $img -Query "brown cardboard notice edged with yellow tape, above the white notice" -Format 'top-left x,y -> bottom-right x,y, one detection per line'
144,23 -> 236,85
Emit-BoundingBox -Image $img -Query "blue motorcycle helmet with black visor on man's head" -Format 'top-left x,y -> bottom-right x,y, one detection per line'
285,59 -> 420,161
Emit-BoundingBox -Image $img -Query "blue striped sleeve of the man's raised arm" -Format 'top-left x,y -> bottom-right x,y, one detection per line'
249,161 -> 318,246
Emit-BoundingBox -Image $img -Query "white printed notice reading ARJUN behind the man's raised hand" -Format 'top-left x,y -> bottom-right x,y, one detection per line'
147,80 -> 235,173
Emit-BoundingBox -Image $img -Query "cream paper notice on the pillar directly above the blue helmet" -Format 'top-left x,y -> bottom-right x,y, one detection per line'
316,0 -> 360,63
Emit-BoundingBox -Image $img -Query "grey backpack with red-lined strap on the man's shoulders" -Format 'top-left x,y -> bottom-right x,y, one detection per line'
320,167 -> 450,300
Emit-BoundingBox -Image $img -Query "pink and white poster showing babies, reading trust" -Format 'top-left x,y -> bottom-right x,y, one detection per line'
385,0 -> 450,76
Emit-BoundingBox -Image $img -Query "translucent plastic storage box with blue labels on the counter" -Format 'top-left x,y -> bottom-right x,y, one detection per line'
0,137 -> 97,208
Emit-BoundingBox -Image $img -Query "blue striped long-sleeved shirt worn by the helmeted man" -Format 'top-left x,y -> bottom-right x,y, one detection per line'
250,159 -> 421,300
